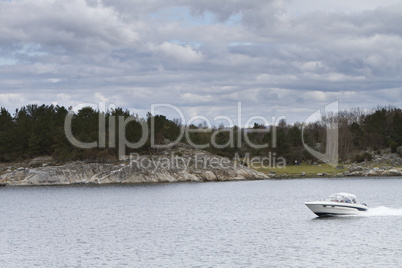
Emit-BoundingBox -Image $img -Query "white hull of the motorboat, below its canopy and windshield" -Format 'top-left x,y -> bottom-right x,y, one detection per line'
305,201 -> 368,217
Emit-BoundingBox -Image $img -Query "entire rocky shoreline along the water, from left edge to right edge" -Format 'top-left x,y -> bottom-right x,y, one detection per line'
0,144 -> 402,186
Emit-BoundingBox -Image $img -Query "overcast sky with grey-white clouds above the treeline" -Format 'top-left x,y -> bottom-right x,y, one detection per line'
0,0 -> 402,123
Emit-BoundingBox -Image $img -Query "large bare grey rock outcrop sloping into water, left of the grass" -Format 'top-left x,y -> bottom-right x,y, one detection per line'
0,144 -> 269,185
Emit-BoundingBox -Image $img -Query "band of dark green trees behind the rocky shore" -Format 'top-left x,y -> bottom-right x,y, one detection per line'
0,104 -> 402,163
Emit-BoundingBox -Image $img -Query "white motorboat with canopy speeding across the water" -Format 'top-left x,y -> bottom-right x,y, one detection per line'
304,193 -> 368,217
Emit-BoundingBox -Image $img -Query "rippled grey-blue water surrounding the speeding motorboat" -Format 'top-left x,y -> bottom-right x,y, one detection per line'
0,178 -> 402,267
